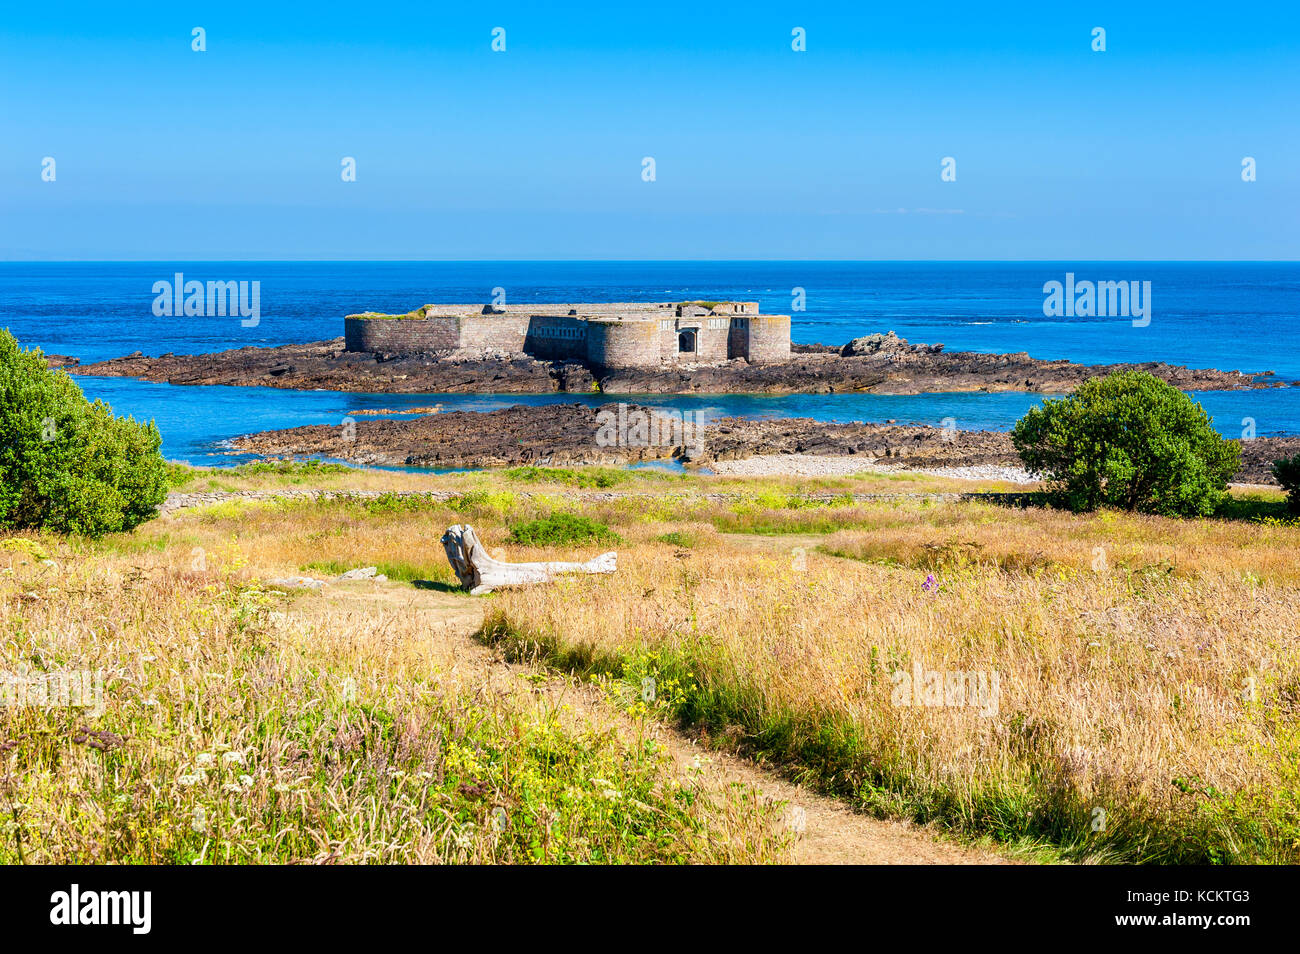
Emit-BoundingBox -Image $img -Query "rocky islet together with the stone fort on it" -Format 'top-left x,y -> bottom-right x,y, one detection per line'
71,302 -> 1286,394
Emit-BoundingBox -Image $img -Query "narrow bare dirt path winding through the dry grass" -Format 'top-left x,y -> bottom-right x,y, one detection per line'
301,582 -> 1010,864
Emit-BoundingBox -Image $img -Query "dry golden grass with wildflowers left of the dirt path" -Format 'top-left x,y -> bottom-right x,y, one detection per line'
0,504 -> 789,863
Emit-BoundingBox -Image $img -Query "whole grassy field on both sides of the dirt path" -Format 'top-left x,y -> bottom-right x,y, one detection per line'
0,465 -> 1300,863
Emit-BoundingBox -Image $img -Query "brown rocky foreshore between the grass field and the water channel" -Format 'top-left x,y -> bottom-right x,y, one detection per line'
231,404 -> 1300,483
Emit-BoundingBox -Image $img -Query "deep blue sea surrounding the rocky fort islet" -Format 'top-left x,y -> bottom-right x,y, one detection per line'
0,261 -> 1300,464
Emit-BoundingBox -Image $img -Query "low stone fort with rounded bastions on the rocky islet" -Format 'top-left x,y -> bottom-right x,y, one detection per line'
345,302 -> 790,368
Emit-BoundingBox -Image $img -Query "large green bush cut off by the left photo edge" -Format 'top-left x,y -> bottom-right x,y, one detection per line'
0,329 -> 168,537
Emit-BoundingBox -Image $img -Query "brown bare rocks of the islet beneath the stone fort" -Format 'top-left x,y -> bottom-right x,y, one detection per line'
71,331 -> 1287,394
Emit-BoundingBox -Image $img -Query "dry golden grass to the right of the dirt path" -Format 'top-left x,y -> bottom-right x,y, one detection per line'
491,503 -> 1300,862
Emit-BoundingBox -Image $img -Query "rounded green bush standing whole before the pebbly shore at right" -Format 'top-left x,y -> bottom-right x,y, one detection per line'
1011,370 -> 1242,516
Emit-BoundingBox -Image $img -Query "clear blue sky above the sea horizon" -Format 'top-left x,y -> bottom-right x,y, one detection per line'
0,0 -> 1300,260
